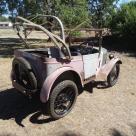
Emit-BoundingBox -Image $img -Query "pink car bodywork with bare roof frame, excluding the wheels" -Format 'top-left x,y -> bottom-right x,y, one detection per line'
11,15 -> 121,103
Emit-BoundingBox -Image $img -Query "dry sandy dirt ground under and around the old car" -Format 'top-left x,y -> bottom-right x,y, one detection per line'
0,29 -> 136,136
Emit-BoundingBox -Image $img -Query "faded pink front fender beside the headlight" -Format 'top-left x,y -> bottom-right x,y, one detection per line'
96,57 -> 122,81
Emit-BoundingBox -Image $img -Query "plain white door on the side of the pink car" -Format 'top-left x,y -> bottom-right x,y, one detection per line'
83,53 -> 99,79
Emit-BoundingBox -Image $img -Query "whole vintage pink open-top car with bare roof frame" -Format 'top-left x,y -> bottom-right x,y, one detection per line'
11,15 -> 122,119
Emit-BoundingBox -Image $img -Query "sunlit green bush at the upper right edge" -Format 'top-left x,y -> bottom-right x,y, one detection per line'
110,2 -> 136,37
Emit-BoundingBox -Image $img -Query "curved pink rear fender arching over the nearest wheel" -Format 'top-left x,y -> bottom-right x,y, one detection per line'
40,67 -> 83,103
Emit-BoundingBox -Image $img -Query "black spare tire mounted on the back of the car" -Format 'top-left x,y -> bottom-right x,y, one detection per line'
12,57 -> 37,93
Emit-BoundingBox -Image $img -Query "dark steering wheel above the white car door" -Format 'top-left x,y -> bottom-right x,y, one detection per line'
79,41 -> 94,54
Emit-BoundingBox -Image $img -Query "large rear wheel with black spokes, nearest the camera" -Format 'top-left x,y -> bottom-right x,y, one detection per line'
48,80 -> 78,119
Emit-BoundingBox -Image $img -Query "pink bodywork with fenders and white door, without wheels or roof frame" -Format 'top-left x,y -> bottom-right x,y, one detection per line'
12,46 -> 119,103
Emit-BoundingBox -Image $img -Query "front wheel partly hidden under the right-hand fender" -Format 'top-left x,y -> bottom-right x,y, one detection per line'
107,63 -> 120,87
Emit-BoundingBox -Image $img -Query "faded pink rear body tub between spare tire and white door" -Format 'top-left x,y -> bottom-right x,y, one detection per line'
14,49 -> 84,83
